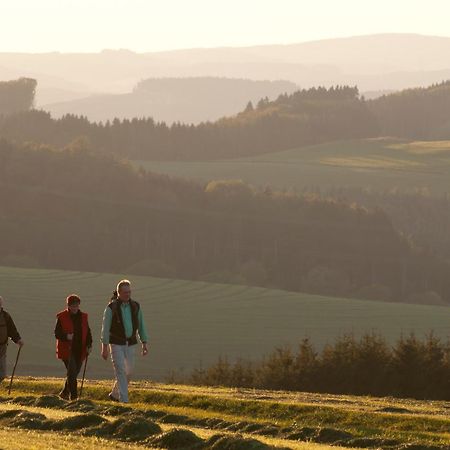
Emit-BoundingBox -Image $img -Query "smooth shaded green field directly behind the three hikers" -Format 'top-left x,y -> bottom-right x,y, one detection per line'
0,267 -> 450,380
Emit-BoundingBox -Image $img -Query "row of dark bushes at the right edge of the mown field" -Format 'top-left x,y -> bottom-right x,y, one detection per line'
185,334 -> 450,400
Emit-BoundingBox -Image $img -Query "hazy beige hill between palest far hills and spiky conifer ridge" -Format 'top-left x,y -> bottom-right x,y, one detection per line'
41,77 -> 297,124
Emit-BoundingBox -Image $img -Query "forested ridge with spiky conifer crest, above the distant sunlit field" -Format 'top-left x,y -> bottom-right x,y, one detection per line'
0,88 -> 377,160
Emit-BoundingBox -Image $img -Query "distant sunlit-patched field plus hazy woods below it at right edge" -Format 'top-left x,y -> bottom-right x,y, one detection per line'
133,138 -> 450,272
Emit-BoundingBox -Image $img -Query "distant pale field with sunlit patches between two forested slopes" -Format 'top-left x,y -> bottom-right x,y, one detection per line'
134,138 -> 450,193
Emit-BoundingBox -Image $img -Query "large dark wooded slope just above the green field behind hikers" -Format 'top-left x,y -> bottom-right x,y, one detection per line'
0,140 -> 450,303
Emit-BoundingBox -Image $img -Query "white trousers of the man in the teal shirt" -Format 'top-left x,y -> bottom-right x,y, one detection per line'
109,344 -> 136,403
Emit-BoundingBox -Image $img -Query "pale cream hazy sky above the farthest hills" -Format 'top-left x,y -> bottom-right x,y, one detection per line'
0,0 -> 450,52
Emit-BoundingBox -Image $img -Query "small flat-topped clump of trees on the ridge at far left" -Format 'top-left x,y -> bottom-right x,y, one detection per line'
0,78 -> 37,115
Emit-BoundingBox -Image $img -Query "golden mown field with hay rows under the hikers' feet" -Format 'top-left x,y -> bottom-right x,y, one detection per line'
0,378 -> 450,450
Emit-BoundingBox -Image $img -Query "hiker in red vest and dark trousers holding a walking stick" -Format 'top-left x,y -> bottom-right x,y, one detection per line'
55,294 -> 92,400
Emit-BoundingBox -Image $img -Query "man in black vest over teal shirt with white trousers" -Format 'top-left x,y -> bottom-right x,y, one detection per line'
101,280 -> 148,403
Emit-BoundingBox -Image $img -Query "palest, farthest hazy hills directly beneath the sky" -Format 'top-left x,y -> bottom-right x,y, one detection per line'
0,34 -> 450,106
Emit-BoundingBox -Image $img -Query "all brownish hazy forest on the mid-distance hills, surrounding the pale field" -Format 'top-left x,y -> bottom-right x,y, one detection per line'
0,80 -> 450,304
